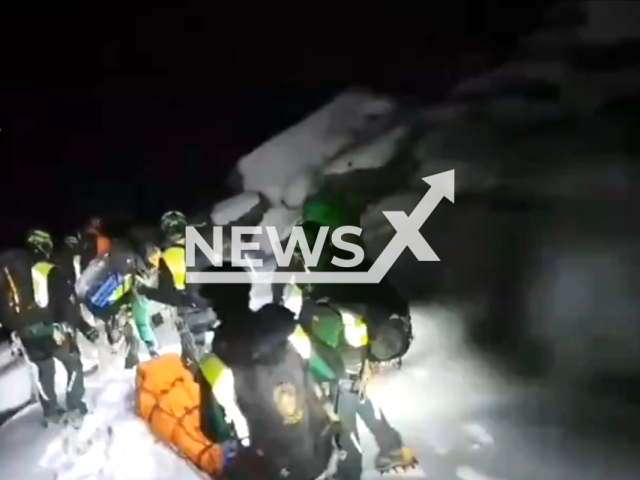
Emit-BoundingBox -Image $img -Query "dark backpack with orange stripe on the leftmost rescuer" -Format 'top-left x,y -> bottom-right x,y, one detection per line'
0,249 -> 36,330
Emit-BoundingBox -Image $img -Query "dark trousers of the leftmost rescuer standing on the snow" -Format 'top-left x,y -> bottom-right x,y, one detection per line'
34,345 -> 86,415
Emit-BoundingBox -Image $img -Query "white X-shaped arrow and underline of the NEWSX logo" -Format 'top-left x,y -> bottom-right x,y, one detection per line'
187,170 -> 455,283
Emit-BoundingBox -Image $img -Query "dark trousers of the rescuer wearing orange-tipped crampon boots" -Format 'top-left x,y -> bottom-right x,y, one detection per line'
337,391 -> 402,480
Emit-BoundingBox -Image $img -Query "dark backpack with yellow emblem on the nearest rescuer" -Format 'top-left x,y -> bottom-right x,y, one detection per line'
214,304 -> 334,479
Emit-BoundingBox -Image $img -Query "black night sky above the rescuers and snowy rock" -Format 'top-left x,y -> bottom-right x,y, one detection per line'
0,0 -> 548,248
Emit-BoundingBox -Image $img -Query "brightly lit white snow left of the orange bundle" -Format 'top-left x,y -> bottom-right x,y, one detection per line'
0,370 -> 201,480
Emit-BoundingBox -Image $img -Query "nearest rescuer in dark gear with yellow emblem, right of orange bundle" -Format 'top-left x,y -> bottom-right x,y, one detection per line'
201,263 -> 339,479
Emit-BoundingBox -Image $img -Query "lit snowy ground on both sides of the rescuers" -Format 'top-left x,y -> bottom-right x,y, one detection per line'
0,303 -> 638,480
